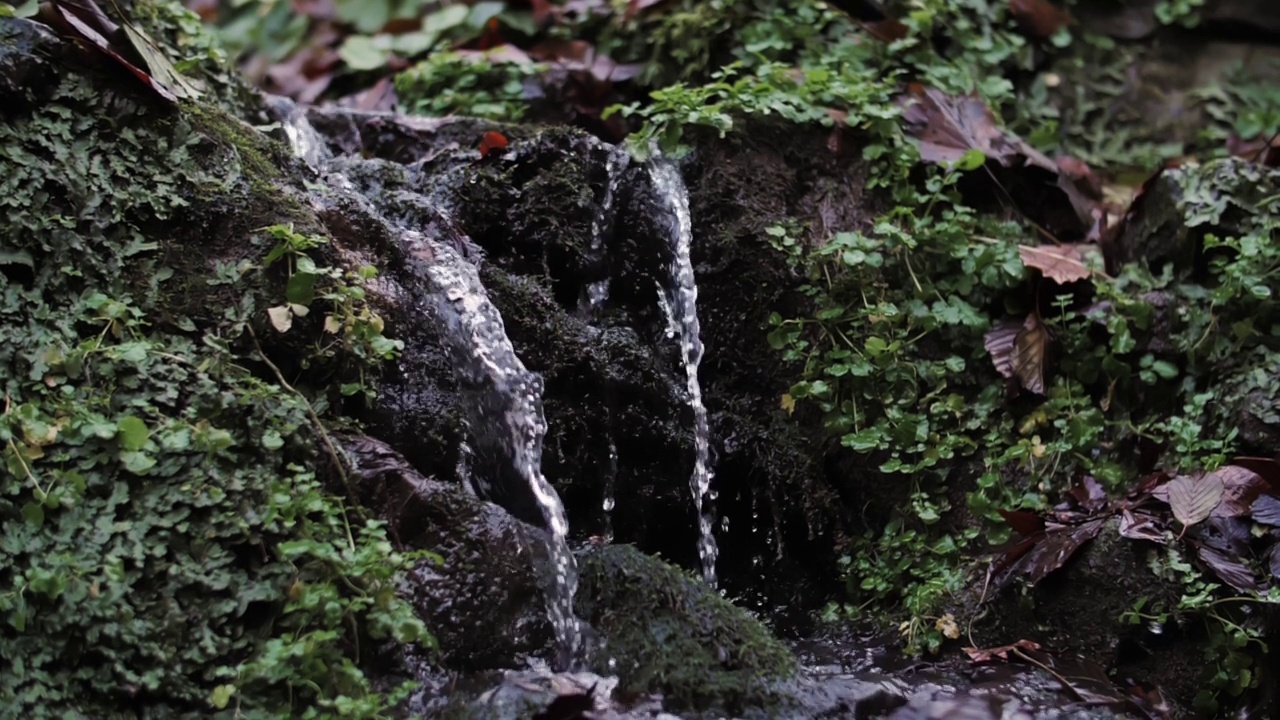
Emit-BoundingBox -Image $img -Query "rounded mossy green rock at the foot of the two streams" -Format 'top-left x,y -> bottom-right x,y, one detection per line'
577,544 -> 796,715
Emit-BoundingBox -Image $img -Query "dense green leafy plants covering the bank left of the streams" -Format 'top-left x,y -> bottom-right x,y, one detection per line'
0,33 -> 428,717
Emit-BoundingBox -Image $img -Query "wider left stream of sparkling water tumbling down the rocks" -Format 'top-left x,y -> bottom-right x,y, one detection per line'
409,226 -> 581,662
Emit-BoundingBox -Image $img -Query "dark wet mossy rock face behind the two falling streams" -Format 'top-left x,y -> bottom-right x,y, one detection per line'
302,110 -> 870,620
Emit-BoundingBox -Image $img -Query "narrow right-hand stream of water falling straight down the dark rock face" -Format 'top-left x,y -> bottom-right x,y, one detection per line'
649,160 -> 719,587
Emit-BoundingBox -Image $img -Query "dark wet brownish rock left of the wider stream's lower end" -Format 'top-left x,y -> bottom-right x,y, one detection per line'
342,436 -> 552,671
